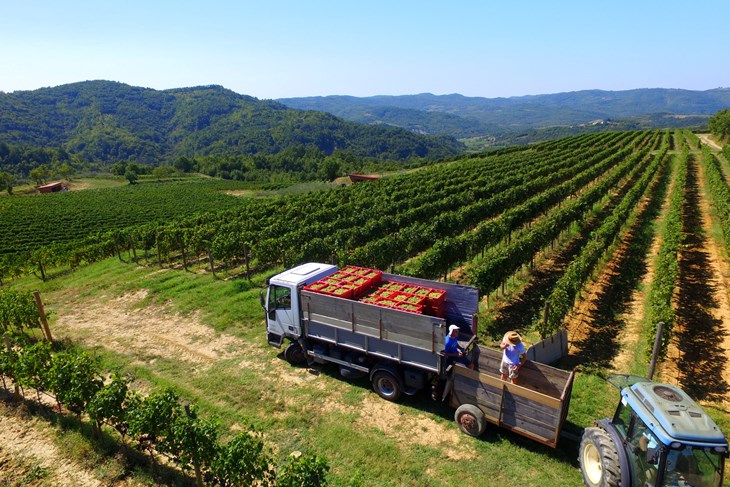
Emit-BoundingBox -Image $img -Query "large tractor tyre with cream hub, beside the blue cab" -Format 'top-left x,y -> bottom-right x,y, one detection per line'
578,428 -> 621,487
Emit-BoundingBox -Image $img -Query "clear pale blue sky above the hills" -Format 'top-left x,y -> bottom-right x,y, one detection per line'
0,0 -> 730,98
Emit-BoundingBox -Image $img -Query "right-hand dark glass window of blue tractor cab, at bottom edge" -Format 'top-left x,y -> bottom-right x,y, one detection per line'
662,447 -> 724,487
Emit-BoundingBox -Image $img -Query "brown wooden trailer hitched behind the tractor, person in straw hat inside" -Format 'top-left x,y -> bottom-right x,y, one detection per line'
444,348 -> 575,448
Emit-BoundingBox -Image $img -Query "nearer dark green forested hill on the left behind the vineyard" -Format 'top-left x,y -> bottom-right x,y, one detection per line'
0,81 -> 463,164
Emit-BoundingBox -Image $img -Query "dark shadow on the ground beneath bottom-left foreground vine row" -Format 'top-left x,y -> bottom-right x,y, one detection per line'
0,388 -> 195,486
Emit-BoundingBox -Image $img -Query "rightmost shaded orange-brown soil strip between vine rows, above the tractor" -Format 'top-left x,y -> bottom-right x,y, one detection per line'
661,157 -> 730,401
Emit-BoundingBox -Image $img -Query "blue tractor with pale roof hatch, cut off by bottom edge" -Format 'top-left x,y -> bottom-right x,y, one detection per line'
578,375 -> 728,487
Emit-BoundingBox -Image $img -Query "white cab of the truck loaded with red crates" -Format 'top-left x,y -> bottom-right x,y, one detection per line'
261,263 -> 337,348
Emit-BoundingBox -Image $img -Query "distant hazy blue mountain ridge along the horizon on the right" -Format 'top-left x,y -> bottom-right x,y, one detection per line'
278,88 -> 730,137
